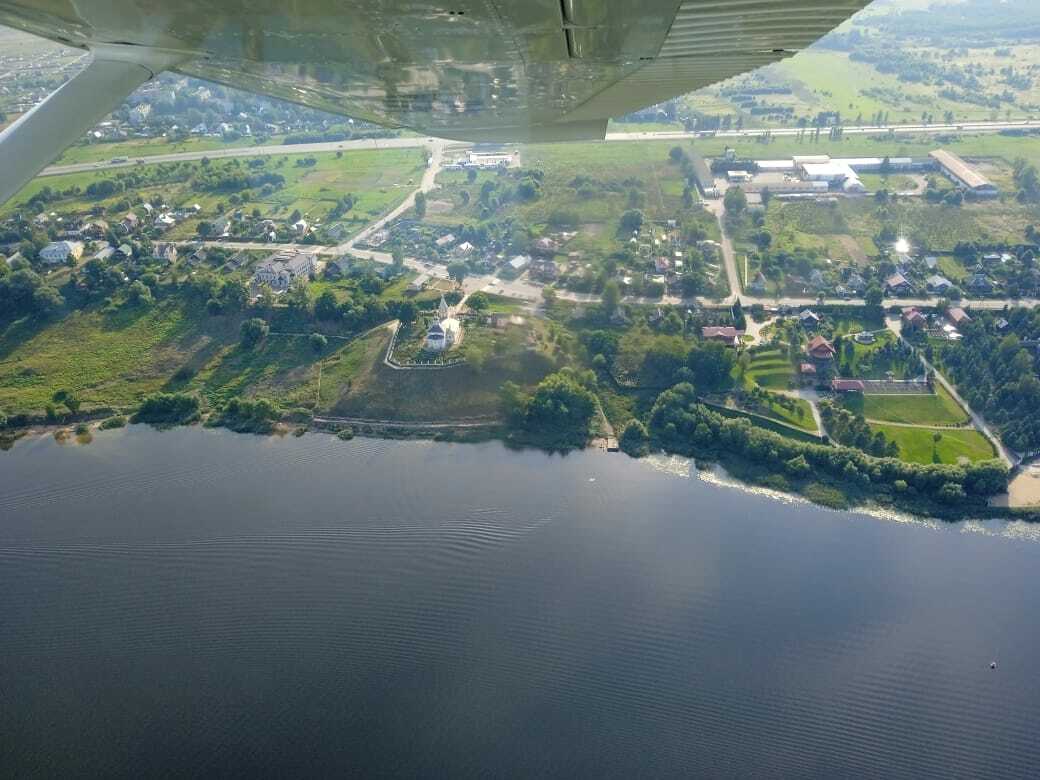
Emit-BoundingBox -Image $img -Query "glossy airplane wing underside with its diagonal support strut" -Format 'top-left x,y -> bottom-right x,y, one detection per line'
0,0 -> 868,203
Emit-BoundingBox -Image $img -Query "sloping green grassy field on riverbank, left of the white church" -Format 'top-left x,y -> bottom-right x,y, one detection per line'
0,300 -> 391,414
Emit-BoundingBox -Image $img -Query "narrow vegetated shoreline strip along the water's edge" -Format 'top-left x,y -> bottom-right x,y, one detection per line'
8,411 -> 1040,523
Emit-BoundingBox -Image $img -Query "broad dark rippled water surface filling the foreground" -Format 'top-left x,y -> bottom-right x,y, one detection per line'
0,427 -> 1040,778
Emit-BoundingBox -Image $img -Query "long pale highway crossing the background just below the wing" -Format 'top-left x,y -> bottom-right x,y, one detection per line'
40,120 -> 1040,176
